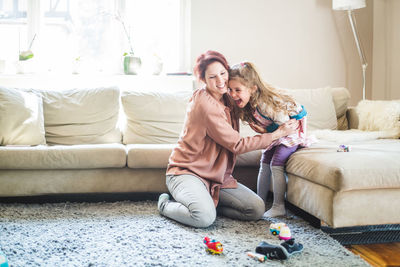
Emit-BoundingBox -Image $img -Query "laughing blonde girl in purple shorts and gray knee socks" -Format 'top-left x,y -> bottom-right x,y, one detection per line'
229,62 -> 311,217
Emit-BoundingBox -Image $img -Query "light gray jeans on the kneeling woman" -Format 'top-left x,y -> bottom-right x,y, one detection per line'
162,174 -> 265,227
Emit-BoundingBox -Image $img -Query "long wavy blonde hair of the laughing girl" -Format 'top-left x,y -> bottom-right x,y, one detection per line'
229,62 -> 296,122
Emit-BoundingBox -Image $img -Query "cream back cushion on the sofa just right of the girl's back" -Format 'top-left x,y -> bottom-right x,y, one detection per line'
285,88 -> 337,130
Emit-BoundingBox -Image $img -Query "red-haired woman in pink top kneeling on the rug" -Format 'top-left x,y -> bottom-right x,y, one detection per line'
158,51 -> 298,227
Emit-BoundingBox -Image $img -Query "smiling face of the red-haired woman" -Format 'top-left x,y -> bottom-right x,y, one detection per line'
204,61 -> 229,100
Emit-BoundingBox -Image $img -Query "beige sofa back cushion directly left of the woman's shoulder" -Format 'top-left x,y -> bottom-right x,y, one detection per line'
121,91 -> 192,144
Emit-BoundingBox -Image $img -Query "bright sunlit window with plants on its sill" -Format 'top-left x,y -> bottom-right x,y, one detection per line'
0,0 -> 189,74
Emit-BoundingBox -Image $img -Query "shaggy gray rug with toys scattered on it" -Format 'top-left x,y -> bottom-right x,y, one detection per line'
0,201 -> 369,266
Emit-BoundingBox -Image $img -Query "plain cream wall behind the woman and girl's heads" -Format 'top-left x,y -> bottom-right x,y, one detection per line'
191,0 -> 372,104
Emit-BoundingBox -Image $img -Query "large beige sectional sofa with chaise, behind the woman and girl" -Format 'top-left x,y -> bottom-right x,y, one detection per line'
0,87 -> 400,230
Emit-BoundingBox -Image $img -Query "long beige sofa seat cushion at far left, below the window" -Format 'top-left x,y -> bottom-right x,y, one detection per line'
0,144 -> 126,169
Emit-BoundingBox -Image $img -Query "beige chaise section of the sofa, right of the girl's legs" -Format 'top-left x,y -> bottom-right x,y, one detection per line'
286,139 -> 400,228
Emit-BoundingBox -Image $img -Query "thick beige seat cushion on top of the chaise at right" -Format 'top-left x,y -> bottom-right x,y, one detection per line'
286,139 -> 400,192
